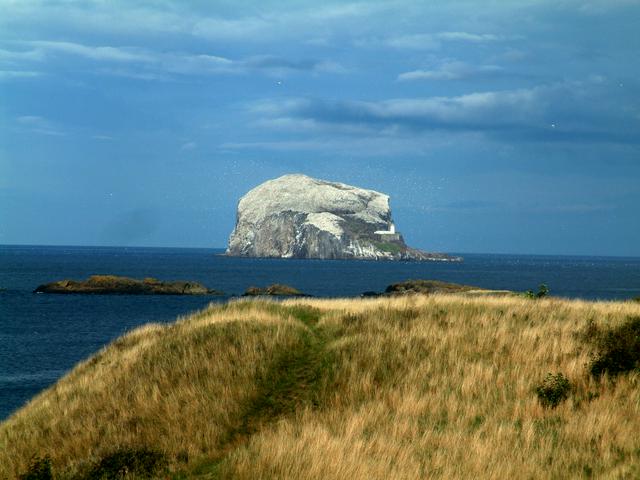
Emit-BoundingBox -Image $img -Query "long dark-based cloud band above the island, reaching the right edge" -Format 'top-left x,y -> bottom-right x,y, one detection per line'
251,82 -> 640,144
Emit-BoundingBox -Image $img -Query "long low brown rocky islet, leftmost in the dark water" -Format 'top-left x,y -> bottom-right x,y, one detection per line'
34,275 -> 224,295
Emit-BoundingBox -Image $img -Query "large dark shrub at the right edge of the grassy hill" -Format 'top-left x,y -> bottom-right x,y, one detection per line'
590,317 -> 640,377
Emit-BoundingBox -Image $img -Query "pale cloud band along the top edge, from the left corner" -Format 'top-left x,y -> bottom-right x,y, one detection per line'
0,0 -> 384,44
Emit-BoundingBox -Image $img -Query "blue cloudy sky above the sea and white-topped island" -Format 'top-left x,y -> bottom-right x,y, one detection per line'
0,0 -> 640,256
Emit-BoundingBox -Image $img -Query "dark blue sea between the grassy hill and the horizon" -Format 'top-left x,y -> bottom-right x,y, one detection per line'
0,246 -> 640,419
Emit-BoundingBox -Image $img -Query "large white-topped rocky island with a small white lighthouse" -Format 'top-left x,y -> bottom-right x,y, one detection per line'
226,174 -> 461,261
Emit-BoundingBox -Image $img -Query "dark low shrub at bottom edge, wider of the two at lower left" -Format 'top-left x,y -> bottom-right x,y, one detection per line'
84,447 -> 168,480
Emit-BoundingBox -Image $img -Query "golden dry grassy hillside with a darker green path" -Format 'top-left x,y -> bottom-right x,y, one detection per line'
0,295 -> 640,480
